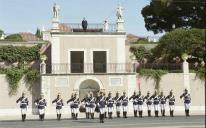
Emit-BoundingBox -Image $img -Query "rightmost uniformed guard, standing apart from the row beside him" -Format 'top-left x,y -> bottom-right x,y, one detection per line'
180,89 -> 191,116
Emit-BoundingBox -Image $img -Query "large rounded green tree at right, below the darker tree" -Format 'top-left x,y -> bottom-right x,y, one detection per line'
151,28 -> 206,62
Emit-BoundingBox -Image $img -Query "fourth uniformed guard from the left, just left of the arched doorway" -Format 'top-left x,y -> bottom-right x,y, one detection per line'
67,93 -> 80,120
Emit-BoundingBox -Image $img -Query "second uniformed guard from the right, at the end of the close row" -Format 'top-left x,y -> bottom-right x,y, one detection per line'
166,90 -> 175,117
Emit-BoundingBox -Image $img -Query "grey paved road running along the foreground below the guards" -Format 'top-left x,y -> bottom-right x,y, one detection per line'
0,115 -> 205,128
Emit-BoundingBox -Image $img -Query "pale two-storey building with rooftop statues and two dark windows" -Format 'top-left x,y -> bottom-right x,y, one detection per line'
41,5 -> 137,107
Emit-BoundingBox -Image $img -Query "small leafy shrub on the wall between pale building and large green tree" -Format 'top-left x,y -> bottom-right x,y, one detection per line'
130,46 -> 151,63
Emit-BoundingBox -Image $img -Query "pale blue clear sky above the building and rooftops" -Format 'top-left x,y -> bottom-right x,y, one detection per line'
0,0 -> 163,37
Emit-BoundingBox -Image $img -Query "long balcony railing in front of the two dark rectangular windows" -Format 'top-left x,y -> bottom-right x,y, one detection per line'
46,63 -> 136,74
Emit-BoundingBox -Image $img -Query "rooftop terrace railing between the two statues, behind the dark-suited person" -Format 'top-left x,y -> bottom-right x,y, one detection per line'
64,23 -> 116,32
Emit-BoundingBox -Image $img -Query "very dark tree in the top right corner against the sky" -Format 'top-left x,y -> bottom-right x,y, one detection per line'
141,0 -> 206,34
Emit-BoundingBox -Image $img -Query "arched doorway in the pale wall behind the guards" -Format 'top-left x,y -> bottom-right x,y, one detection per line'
79,79 -> 100,100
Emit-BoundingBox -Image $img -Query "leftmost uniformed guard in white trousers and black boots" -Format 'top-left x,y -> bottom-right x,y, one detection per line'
16,92 -> 29,122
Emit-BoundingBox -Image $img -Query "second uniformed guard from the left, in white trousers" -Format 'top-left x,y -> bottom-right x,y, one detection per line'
34,94 -> 47,121
